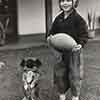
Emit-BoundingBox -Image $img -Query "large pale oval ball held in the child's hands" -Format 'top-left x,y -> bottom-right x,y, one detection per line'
49,33 -> 77,50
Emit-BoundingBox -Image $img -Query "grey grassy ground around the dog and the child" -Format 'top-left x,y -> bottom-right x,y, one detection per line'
0,41 -> 100,100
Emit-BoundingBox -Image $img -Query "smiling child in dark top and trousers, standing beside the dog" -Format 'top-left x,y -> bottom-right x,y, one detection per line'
47,0 -> 88,100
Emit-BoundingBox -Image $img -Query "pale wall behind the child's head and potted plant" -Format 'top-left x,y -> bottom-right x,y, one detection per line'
53,0 -> 100,28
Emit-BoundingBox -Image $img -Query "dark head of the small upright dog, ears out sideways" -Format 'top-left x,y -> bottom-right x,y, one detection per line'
20,57 -> 42,68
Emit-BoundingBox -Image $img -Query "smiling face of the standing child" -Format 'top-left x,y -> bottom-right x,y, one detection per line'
60,0 -> 75,12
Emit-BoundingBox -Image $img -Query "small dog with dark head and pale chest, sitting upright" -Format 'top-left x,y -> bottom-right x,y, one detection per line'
20,57 -> 42,100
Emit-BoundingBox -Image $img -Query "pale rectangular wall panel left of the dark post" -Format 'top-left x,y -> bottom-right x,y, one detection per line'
18,0 -> 45,35
